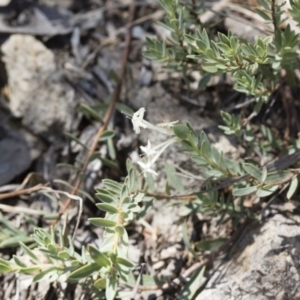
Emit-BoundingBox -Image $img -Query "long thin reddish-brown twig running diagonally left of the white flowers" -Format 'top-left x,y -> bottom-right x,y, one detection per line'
52,5 -> 135,225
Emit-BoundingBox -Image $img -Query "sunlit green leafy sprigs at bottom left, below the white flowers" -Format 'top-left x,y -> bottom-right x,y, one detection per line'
0,168 -> 144,299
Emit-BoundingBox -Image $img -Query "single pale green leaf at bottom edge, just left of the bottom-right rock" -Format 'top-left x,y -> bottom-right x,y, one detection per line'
178,266 -> 205,300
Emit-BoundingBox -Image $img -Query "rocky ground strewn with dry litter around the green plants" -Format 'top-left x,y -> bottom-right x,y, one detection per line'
0,0 -> 300,300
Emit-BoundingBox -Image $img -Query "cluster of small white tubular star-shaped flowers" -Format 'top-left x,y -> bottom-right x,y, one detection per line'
131,108 -> 177,177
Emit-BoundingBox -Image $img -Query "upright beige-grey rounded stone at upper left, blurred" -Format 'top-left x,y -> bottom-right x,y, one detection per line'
1,35 -> 76,139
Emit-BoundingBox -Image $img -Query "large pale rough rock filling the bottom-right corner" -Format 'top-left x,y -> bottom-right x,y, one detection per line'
197,214 -> 300,300
